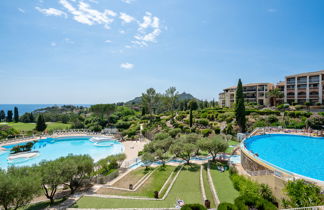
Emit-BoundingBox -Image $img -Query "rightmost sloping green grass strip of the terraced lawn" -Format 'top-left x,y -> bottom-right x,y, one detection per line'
210,164 -> 239,203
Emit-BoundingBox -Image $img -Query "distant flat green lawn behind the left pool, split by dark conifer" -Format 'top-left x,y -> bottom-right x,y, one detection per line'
6,122 -> 71,132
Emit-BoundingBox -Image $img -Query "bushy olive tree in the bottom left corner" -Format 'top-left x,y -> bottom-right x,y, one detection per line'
0,167 -> 40,210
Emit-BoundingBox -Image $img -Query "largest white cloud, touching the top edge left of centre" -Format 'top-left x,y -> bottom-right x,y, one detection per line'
59,0 -> 116,29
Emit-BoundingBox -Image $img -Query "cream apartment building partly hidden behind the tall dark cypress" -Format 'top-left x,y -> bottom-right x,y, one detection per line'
218,83 -> 273,107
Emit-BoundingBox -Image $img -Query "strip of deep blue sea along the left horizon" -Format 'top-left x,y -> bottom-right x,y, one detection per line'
0,104 -> 91,116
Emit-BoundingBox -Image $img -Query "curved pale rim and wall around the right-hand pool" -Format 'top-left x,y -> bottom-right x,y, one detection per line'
240,133 -> 324,187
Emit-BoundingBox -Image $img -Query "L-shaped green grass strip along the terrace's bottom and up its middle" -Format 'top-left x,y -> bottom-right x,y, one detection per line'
75,165 -> 202,208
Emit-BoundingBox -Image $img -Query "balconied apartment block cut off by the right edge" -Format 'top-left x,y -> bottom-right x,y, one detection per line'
284,70 -> 324,104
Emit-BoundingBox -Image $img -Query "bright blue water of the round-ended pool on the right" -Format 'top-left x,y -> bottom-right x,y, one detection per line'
244,134 -> 324,181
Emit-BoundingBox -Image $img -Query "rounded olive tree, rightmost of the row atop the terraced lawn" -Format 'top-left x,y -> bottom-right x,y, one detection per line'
198,136 -> 228,161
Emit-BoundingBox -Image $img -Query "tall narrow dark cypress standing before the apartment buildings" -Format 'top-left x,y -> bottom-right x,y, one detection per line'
235,79 -> 246,133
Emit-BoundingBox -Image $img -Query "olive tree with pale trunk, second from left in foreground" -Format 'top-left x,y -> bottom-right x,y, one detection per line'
39,160 -> 66,205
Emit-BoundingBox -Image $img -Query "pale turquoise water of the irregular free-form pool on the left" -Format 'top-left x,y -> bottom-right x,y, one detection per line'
0,137 -> 124,169
